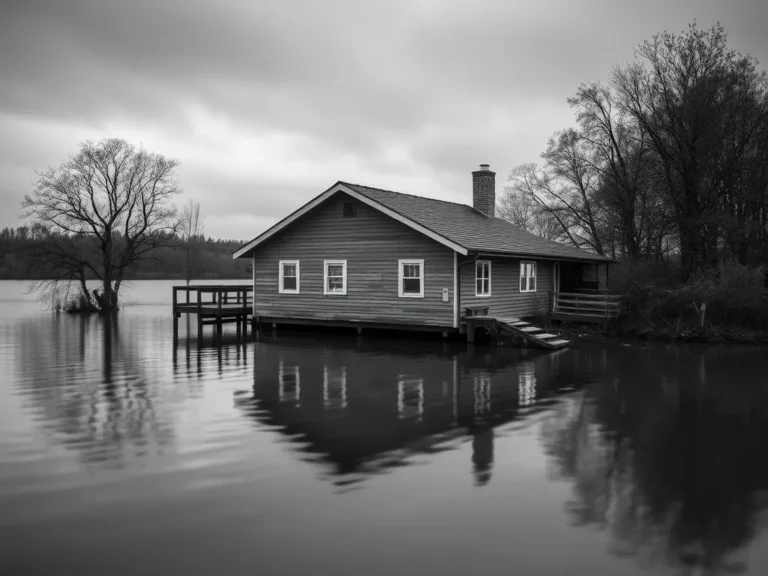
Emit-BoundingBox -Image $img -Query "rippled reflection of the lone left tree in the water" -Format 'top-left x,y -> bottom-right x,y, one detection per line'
16,316 -> 175,468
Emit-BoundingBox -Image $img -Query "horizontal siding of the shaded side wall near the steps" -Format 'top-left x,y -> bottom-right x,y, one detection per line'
459,258 -> 554,318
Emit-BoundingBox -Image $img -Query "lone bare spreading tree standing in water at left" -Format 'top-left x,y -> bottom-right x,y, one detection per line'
23,139 -> 180,312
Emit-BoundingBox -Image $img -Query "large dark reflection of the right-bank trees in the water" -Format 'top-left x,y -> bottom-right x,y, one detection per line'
542,347 -> 768,574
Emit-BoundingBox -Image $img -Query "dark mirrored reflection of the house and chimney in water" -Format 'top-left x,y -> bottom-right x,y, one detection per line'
236,336 -> 584,485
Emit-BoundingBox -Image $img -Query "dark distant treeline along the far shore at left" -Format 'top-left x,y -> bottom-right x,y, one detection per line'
0,226 -> 251,280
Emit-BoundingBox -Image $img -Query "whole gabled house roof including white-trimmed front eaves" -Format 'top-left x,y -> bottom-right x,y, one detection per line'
233,182 -> 612,262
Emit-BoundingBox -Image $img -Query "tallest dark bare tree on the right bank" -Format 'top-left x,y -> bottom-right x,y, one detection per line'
613,23 -> 768,276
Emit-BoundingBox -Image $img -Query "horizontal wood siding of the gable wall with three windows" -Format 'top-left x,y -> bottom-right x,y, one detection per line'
253,193 -> 454,327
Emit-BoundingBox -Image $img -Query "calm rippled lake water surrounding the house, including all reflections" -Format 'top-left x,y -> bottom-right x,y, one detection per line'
0,282 -> 768,576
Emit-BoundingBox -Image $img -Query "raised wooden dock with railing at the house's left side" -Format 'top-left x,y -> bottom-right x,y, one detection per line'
173,284 -> 253,341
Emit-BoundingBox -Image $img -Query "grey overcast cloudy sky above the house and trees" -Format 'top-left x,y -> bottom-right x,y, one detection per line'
0,0 -> 768,239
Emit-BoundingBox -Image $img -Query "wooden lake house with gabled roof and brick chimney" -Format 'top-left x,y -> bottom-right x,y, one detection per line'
233,165 -> 611,333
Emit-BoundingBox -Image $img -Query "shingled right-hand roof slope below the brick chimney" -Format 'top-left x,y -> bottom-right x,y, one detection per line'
339,182 -> 612,262
